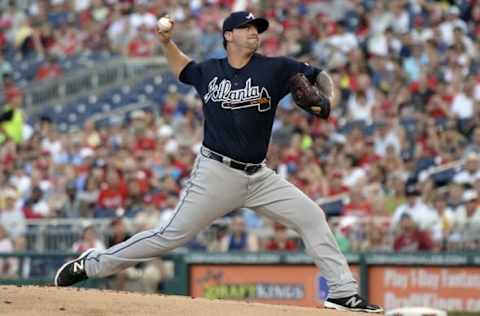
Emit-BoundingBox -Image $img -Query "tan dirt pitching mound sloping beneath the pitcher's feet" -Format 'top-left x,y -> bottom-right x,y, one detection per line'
0,286 -> 372,316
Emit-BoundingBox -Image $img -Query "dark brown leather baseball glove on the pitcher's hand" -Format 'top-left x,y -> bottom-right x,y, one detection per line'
288,73 -> 330,119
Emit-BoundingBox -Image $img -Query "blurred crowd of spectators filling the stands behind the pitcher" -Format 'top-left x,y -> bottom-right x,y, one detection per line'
0,0 -> 480,278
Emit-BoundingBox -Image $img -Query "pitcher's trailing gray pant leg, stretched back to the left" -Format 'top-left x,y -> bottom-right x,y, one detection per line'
85,157 -> 246,277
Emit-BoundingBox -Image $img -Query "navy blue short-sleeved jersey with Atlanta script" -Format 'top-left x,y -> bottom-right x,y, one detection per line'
179,54 -> 320,163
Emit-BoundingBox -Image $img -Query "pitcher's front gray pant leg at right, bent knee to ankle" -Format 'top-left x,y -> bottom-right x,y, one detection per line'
246,170 -> 358,298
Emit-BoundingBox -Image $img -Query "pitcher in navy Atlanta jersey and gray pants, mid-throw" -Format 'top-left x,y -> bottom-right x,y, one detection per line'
55,11 -> 383,313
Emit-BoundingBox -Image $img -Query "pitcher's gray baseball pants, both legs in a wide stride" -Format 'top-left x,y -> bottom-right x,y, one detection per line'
85,147 -> 358,298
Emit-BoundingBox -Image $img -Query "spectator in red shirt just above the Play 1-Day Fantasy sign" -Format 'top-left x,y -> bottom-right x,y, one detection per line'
393,213 -> 433,251
